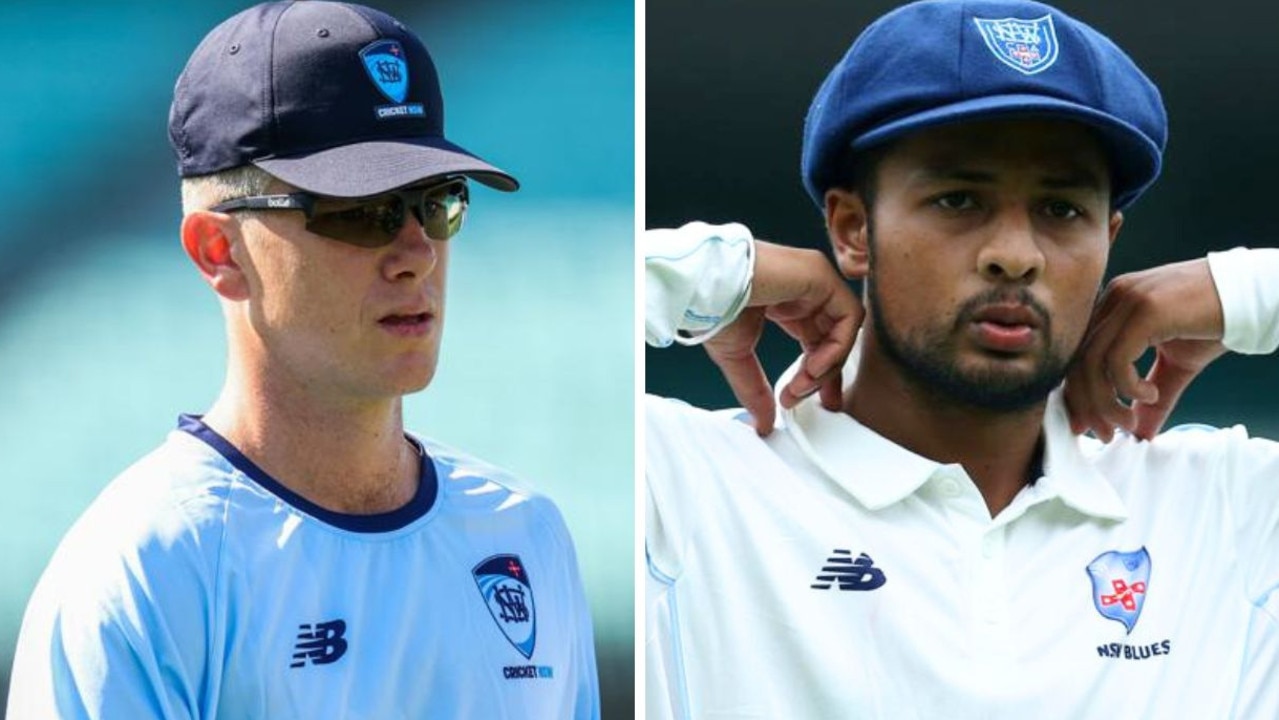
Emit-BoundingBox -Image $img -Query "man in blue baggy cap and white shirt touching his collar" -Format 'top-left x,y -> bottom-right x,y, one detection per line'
645,0 -> 1279,720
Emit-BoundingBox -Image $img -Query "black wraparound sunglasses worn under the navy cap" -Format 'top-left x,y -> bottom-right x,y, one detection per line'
210,178 -> 471,248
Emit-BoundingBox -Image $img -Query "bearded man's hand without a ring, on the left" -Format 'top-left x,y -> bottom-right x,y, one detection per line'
706,240 -> 862,435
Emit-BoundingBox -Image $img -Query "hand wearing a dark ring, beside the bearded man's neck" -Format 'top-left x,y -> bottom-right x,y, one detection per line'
1065,260 -> 1225,442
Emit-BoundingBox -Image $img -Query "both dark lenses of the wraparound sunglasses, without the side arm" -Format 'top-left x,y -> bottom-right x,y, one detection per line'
307,180 -> 467,248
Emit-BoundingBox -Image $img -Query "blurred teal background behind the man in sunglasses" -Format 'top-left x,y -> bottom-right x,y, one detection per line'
0,0 -> 634,717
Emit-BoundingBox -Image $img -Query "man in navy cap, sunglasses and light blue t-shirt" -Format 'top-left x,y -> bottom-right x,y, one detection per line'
8,0 -> 600,720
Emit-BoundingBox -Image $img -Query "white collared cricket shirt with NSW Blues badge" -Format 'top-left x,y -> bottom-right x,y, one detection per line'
646,222 -> 1279,720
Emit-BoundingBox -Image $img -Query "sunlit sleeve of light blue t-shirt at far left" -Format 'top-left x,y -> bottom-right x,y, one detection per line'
8,496 -> 211,720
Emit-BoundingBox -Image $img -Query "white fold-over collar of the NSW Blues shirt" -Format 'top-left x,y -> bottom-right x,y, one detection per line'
775,343 -> 1128,520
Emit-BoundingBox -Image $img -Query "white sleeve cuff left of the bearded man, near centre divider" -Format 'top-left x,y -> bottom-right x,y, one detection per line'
643,223 -> 755,348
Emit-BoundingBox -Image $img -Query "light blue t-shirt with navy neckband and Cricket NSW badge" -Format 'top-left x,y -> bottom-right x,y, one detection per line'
8,417 -> 600,720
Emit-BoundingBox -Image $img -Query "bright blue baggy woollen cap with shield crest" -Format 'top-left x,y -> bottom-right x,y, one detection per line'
802,0 -> 1168,208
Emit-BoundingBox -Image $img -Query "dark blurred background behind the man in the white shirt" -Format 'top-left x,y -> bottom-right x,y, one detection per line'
645,0 -> 1279,437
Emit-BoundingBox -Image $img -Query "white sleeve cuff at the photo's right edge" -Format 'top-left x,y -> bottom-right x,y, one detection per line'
1207,248 -> 1279,354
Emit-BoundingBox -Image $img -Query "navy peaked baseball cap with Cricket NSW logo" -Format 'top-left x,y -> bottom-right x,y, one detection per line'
169,0 -> 519,197
